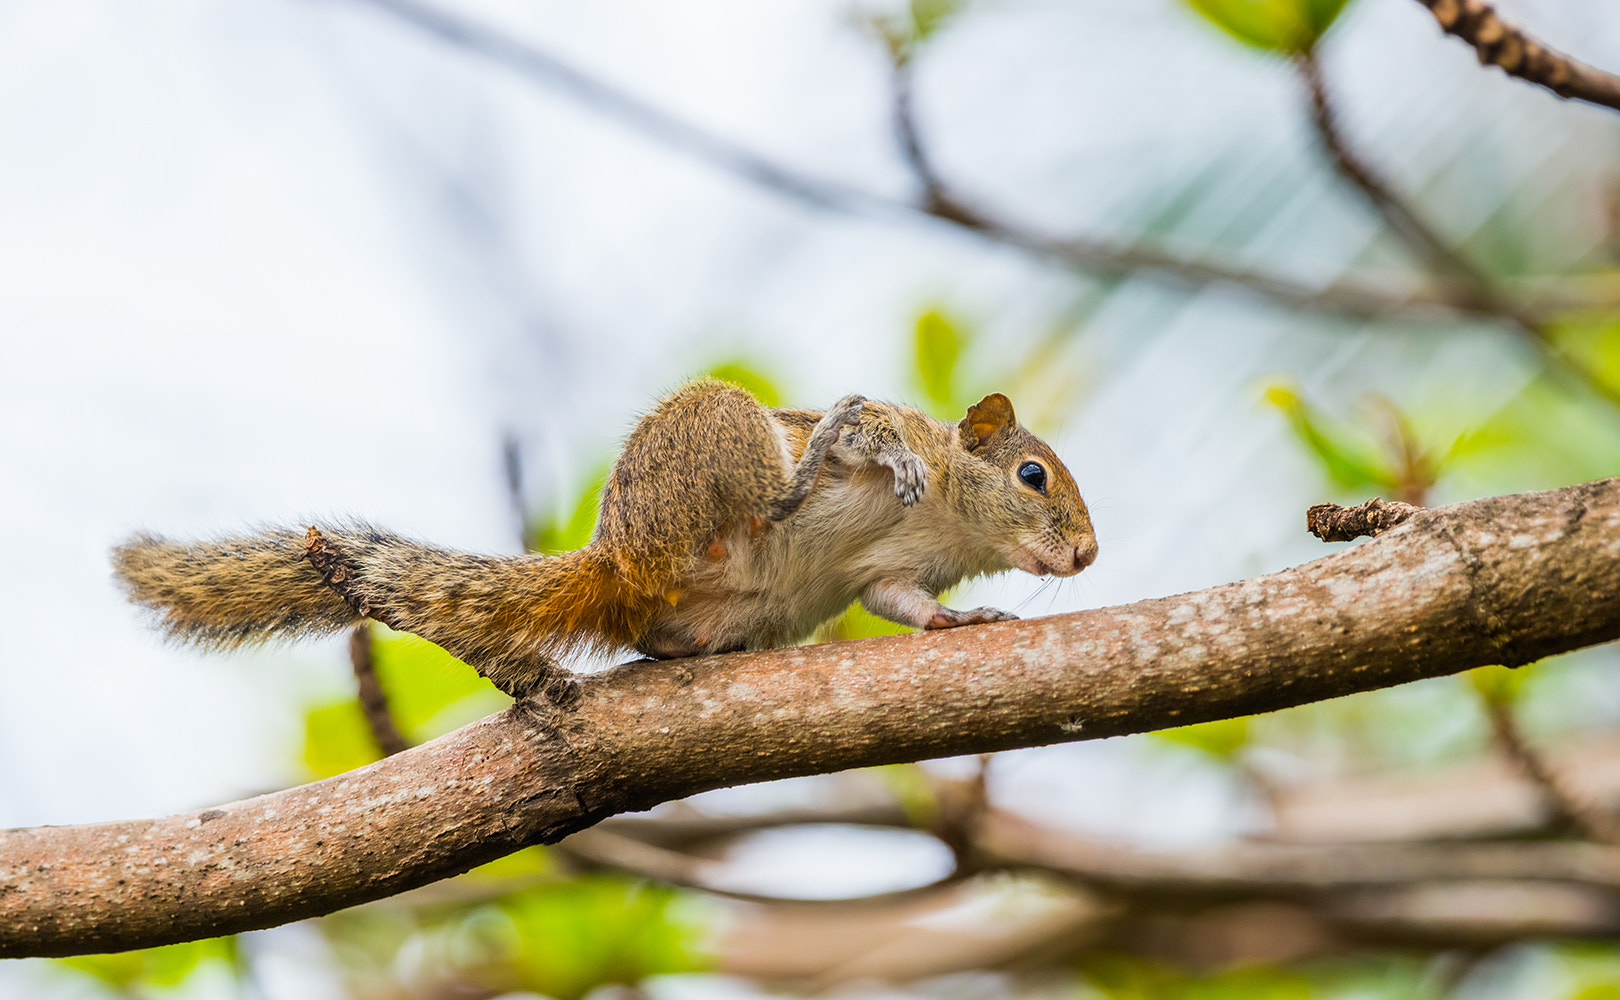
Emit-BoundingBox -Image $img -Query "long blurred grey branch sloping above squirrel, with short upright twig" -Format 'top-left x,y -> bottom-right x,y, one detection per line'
341,0 -> 1476,319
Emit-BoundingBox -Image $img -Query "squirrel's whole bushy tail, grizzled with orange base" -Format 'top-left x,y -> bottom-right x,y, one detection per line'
113,524 -> 659,684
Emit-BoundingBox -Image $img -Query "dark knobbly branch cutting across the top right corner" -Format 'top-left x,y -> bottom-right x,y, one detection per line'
1418,0 -> 1620,110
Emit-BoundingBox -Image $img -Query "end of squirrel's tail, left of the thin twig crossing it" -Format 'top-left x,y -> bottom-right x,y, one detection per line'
112,528 -> 360,648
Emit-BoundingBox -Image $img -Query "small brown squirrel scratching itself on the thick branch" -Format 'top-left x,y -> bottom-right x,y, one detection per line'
113,379 -> 1097,702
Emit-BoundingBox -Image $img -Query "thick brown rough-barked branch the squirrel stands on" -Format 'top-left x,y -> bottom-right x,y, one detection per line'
0,478 -> 1620,956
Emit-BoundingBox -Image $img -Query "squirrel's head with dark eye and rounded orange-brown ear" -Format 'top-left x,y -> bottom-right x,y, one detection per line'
953,392 -> 1097,577
